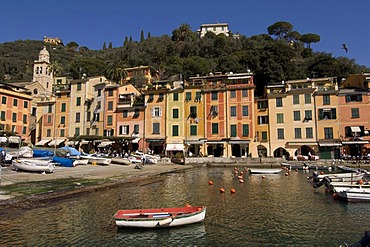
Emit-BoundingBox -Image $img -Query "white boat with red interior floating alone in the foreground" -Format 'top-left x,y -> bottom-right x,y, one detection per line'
113,206 -> 206,228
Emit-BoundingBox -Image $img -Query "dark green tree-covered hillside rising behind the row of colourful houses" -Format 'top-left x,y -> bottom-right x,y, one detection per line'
0,22 -> 369,94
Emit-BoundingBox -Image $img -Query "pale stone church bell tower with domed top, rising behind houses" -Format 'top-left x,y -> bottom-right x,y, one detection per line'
33,46 -> 53,93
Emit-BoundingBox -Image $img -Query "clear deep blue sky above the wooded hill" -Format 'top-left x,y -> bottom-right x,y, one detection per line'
0,0 -> 370,68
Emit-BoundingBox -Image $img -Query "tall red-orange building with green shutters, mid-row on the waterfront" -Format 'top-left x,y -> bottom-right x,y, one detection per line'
190,73 -> 254,157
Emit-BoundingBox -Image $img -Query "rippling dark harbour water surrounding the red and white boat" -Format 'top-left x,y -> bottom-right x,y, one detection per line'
0,167 -> 370,246
